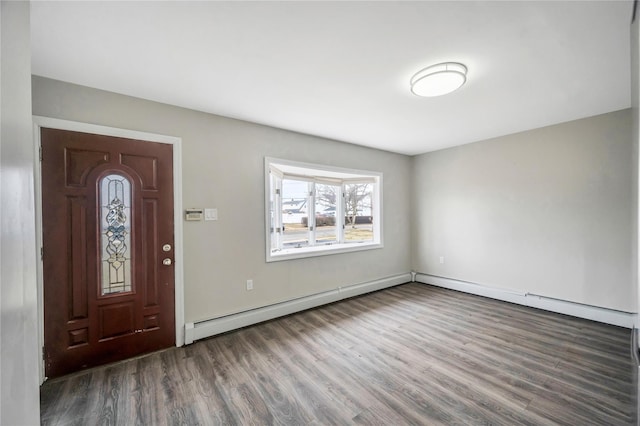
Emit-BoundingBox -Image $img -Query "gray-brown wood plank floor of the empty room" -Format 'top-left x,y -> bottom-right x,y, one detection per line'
41,283 -> 636,425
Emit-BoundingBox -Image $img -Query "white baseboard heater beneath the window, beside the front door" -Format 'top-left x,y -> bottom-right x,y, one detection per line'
184,273 -> 411,345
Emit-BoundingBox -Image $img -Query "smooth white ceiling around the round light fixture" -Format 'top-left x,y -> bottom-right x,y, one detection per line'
31,1 -> 633,154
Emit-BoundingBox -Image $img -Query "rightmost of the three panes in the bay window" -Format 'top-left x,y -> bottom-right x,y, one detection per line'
344,183 -> 373,243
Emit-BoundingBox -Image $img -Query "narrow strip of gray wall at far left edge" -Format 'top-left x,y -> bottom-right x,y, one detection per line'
0,1 -> 40,425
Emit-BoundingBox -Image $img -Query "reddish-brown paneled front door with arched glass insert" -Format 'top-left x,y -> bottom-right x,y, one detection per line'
41,128 -> 175,377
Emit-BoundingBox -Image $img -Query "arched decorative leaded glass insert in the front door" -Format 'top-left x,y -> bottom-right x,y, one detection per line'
99,174 -> 131,296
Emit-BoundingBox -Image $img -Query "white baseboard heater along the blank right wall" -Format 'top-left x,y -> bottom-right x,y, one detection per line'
416,273 -> 637,328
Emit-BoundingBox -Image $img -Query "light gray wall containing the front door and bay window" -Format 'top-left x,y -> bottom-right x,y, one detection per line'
32,77 -> 411,322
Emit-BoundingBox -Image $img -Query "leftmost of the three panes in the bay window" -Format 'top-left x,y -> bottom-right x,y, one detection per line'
282,179 -> 309,249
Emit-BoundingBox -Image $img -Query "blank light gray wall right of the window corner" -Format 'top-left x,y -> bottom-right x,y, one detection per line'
412,110 -> 637,312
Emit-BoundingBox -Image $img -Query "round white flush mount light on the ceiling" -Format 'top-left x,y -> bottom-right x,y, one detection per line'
411,62 -> 467,97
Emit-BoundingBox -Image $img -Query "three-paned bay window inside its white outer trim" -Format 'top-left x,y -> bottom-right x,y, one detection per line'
268,158 -> 380,262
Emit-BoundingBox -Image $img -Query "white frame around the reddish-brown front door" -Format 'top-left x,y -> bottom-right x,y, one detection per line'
33,115 -> 184,384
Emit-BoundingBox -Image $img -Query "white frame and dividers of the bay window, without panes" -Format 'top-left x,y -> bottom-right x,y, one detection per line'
264,157 -> 383,262
